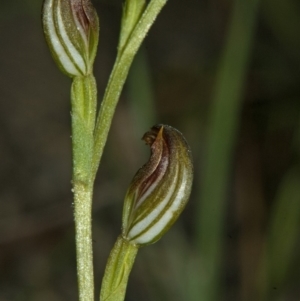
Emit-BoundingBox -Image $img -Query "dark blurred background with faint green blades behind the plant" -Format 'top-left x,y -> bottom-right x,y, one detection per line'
0,0 -> 300,301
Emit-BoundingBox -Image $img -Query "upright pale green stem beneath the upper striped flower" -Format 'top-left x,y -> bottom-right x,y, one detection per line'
71,75 -> 97,301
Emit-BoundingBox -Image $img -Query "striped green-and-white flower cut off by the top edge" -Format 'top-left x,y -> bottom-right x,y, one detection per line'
43,0 -> 99,77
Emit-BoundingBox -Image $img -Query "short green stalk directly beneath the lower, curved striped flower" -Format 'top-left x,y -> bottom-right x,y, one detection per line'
100,236 -> 138,301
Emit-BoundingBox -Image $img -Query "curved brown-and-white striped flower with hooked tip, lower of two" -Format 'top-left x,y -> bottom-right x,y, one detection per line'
122,125 -> 193,245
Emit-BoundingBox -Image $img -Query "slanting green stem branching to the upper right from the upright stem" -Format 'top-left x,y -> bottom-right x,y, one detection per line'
92,0 -> 167,177
